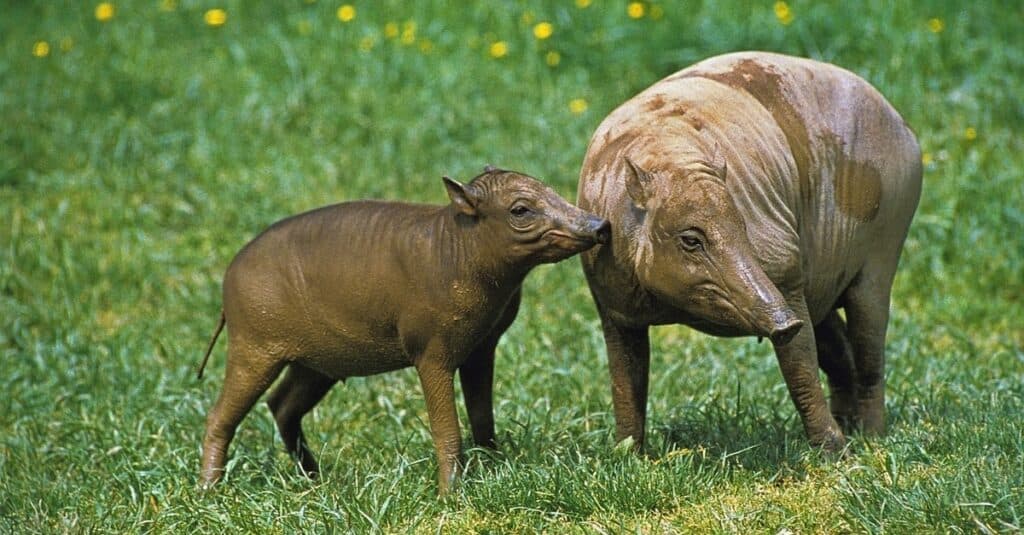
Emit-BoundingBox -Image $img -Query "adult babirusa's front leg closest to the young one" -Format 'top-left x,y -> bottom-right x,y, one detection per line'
601,314 -> 650,451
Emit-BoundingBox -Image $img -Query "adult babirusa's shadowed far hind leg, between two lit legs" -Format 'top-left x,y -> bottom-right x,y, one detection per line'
814,311 -> 858,433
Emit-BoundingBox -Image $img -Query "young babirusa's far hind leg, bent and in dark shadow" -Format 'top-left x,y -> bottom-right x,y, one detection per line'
266,364 -> 335,478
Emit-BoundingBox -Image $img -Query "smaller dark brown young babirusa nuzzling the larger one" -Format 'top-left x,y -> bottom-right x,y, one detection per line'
200,167 -> 609,494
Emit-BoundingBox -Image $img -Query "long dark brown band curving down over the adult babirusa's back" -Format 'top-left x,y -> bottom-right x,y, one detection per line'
678,59 -> 811,201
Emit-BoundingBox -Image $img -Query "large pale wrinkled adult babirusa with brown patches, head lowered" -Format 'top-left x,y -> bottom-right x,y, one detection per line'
579,52 -> 922,451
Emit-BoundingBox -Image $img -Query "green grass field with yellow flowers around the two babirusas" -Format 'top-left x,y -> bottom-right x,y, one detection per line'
0,0 -> 1024,533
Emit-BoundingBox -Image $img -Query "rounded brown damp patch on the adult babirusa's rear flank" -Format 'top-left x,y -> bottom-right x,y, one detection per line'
822,132 -> 882,221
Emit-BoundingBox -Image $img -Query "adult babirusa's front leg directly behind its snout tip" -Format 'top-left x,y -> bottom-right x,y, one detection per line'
775,294 -> 846,452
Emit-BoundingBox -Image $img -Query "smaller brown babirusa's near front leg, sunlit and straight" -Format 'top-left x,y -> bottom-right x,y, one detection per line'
416,355 -> 462,495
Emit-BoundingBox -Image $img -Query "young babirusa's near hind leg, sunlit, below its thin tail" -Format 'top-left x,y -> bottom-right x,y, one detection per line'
200,348 -> 282,488
